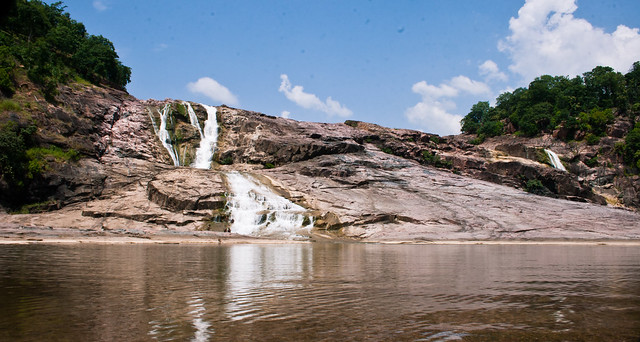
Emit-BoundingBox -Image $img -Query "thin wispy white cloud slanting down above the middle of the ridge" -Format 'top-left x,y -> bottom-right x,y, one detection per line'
278,74 -> 353,117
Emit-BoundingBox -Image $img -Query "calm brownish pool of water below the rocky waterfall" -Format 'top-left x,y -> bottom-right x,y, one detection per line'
0,243 -> 640,341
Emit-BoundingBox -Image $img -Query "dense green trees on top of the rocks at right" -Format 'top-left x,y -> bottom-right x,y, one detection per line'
461,62 -> 640,167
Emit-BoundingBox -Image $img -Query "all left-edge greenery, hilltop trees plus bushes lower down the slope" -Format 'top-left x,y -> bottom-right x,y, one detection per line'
0,0 -> 124,208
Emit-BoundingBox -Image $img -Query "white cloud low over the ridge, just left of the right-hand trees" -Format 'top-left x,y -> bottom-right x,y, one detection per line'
405,76 -> 491,135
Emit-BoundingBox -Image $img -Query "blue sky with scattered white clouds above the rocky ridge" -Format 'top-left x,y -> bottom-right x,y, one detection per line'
46,0 -> 640,135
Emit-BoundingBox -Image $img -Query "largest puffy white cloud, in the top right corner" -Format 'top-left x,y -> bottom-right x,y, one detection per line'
498,0 -> 640,80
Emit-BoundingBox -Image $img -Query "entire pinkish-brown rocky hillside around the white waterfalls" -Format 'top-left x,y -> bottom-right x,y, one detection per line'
0,81 -> 640,241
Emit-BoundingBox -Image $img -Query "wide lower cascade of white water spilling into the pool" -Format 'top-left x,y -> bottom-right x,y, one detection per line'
226,172 -> 313,238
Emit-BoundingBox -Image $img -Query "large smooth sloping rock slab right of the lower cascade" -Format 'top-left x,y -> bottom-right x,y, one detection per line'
259,149 -> 640,241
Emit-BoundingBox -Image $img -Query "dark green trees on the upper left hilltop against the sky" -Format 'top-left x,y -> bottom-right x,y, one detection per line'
0,0 -> 131,98
